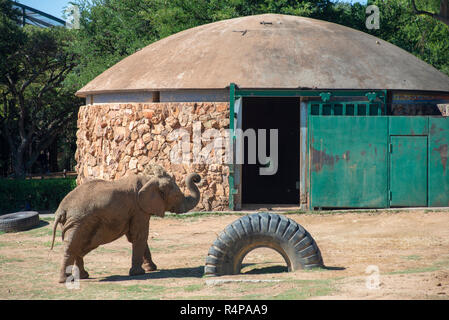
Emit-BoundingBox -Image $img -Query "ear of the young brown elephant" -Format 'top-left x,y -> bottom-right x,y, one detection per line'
137,179 -> 165,217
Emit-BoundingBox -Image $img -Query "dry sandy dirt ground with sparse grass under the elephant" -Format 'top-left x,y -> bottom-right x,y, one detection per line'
0,209 -> 449,300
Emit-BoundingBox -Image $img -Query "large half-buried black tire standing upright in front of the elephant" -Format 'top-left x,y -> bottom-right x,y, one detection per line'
204,212 -> 323,276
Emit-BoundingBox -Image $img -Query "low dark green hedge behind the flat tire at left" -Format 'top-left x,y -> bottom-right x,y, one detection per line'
0,178 -> 76,214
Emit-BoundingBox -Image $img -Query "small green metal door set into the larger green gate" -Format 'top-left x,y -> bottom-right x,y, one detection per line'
390,136 -> 427,207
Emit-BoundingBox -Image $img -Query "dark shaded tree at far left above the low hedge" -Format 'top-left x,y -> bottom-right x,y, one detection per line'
0,0 -> 79,177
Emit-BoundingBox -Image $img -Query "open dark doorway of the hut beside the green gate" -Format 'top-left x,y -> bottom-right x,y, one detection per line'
242,97 -> 300,204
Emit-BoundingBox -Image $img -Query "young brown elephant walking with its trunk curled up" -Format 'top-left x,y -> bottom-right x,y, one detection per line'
51,164 -> 201,283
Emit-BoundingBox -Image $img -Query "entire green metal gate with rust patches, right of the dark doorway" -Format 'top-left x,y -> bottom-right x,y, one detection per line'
309,112 -> 449,208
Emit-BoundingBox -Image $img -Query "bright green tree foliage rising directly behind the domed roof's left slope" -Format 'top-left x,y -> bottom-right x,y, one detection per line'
65,0 -> 340,89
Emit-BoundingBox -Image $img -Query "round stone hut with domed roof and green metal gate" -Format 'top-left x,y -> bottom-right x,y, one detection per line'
76,14 -> 449,211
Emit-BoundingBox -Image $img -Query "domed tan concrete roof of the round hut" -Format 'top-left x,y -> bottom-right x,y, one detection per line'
77,14 -> 449,97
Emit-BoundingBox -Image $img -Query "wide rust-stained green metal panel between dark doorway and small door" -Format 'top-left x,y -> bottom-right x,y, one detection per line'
309,115 -> 388,208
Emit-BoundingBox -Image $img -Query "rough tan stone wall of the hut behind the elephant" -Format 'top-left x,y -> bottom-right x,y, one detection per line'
75,102 -> 229,211
